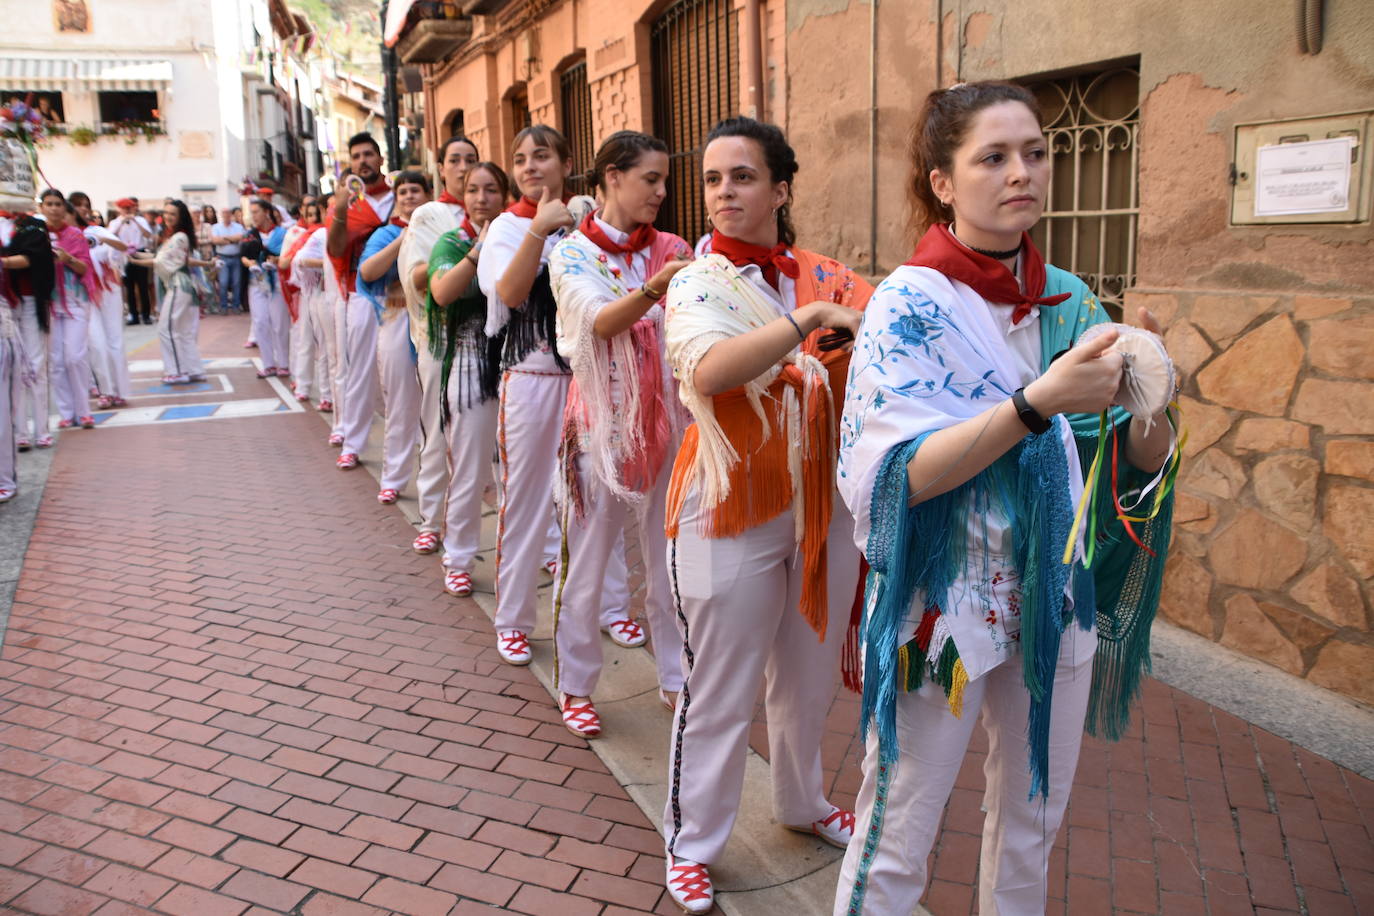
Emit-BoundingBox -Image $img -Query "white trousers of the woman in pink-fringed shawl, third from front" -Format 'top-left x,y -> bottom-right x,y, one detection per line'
554,455 -> 683,696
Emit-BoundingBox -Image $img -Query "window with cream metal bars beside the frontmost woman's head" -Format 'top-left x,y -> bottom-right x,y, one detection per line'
1025,65 -> 1140,316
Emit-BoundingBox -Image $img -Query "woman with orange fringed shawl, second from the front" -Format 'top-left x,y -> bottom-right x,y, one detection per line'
664,118 -> 872,913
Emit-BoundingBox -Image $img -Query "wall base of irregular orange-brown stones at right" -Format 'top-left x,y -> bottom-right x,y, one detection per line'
1127,290 -> 1374,703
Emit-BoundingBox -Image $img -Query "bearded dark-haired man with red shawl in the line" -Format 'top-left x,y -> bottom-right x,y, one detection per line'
326,133 -> 396,471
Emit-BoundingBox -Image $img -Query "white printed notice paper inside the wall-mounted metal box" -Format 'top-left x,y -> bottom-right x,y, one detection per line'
1254,137 -> 1355,216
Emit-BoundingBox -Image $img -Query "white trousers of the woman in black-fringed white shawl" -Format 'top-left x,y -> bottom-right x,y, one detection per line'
496,369 -> 570,633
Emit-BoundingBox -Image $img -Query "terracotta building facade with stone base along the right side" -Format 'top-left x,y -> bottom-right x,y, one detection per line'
387,0 -> 1374,703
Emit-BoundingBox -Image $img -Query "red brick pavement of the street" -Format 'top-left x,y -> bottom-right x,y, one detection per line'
0,319 -> 1374,916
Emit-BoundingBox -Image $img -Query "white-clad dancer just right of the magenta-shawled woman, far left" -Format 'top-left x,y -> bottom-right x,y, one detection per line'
67,191 -> 129,411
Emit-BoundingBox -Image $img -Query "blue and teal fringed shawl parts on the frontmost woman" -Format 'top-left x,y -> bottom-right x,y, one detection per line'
861,265 -> 1172,795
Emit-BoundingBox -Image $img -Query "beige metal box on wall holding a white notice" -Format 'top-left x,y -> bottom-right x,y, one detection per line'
1231,111 -> 1374,225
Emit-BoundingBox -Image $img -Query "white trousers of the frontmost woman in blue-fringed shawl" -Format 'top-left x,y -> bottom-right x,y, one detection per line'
834,632 -> 1095,916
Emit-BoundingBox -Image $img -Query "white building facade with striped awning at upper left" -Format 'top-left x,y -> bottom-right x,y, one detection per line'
0,0 -> 320,206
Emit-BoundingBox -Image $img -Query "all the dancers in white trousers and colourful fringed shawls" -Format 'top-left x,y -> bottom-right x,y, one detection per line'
0,84 -> 1176,916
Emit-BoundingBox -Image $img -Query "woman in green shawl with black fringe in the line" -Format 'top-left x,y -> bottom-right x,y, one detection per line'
422,162 -> 510,597
